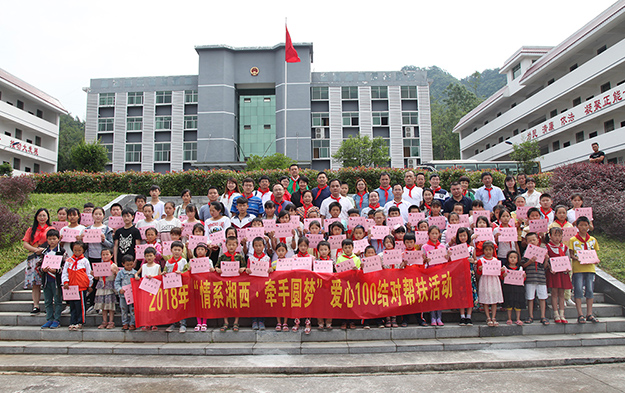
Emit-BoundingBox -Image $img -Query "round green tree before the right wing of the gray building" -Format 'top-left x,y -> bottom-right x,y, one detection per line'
332,136 -> 391,167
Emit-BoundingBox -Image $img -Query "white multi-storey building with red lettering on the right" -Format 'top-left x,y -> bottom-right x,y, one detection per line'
454,1 -> 625,170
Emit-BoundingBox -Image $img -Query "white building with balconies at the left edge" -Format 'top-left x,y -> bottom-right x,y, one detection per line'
0,69 -> 67,175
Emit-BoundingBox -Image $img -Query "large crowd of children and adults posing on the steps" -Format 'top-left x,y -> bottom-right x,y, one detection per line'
23,165 -> 599,334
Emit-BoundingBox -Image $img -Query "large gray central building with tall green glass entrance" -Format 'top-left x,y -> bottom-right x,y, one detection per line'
85,44 -> 432,172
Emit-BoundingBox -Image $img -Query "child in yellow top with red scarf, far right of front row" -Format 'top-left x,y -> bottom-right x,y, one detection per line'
569,217 -> 599,323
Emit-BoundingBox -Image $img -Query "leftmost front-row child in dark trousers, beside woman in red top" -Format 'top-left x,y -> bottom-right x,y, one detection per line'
41,229 -> 66,329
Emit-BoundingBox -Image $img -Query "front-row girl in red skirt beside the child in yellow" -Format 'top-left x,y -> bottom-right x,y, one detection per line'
543,225 -> 573,324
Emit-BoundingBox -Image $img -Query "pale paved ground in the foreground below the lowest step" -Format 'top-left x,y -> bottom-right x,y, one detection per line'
0,364 -> 625,393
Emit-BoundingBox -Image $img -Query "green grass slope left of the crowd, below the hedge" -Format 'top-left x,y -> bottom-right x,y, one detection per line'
0,193 -> 119,275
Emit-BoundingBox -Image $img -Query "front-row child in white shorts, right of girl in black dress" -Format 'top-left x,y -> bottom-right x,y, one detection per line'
521,230 -> 549,326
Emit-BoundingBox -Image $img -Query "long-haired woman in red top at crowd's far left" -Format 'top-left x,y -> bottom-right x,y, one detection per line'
22,208 -> 54,314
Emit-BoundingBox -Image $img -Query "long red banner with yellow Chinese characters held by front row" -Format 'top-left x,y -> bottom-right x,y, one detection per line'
132,259 -> 473,326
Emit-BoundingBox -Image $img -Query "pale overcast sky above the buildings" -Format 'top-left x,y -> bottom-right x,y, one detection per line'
0,0 -> 614,119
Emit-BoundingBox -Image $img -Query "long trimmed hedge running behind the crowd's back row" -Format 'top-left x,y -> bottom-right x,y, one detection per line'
29,167 -> 550,196
